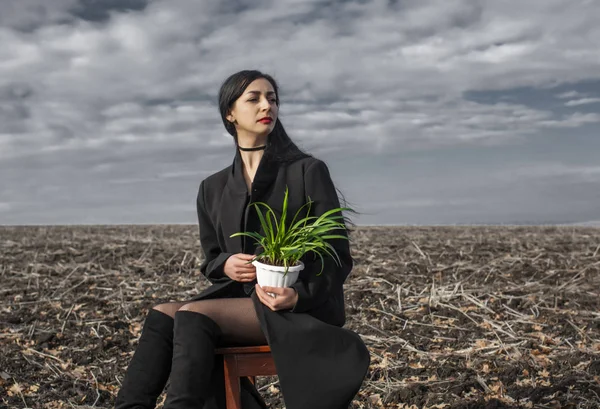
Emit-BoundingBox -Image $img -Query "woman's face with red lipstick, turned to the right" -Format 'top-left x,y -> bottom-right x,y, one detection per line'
227,78 -> 279,137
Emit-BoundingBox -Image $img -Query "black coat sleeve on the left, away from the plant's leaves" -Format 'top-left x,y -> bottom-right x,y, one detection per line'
196,181 -> 233,284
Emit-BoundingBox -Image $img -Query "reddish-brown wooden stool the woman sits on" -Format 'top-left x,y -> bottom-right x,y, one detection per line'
215,345 -> 277,409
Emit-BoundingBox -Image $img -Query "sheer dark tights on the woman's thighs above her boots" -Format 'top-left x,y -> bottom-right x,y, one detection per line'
154,298 -> 267,345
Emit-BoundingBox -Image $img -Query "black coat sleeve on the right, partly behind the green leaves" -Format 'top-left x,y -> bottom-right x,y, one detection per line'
291,160 -> 352,312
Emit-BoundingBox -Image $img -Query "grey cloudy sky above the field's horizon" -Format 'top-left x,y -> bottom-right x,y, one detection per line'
0,0 -> 600,225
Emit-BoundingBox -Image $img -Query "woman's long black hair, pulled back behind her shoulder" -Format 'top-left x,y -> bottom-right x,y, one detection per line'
219,70 -> 358,235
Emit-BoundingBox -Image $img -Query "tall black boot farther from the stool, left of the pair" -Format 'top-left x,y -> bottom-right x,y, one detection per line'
115,309 -> 174,409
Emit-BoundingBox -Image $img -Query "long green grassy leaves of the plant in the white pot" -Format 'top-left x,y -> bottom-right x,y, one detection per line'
230,186 -> 353,275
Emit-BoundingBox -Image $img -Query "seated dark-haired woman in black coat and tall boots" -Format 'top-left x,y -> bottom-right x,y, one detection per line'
116,71 -> 370,409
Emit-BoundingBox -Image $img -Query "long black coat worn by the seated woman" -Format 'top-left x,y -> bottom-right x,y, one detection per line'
193,148 -> 370,409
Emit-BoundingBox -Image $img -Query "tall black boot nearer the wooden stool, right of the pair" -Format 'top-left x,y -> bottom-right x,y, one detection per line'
164,311 -> 222,409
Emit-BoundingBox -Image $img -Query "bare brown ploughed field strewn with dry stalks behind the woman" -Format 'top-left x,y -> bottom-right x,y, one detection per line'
0,225 -> 600,409
